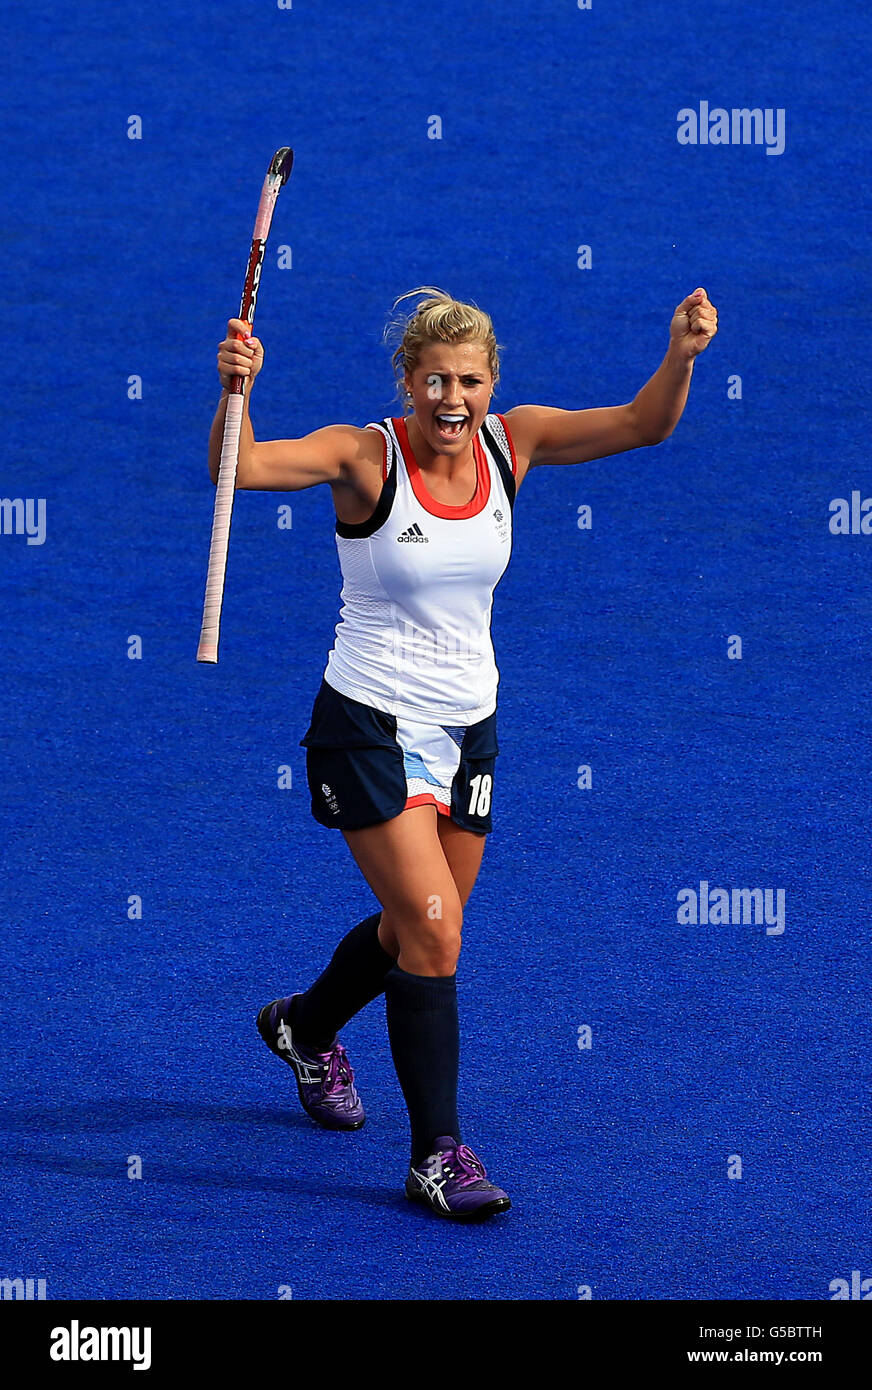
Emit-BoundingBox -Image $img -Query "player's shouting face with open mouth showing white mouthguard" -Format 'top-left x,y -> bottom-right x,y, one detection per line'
406,343 -> 494,455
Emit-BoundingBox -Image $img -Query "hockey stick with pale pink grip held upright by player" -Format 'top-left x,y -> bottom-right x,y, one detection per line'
197,145 -> 293,662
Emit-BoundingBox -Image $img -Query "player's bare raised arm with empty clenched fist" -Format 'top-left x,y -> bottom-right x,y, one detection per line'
506,289 -> 718,468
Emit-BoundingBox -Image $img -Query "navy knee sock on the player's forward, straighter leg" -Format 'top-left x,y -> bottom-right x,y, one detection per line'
384,965 -> 460,1166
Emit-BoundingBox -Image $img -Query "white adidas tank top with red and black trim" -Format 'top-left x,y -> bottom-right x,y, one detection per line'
324,414 -> 516,726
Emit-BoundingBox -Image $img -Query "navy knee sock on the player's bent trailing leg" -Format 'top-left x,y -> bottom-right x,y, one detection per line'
289,912 -> 394,1052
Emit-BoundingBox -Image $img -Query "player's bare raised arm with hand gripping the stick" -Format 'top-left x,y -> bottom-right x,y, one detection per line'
209,318 -> 373,492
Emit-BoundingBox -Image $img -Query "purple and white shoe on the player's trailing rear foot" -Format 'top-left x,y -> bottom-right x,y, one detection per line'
257,995 -> 366,1130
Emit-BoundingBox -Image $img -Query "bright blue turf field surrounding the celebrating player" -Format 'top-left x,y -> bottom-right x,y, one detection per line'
0,0 -> 872,1300
